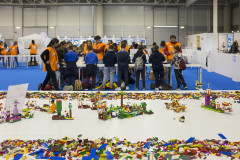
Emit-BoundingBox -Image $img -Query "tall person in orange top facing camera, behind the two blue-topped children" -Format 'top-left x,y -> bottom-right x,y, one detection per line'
92,36 -> 106,85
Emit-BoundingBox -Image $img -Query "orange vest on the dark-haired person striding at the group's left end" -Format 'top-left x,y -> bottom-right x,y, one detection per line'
43,47 -> 58,72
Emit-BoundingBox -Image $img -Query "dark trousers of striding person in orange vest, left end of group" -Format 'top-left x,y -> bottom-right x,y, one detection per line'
41,64 -> 60,90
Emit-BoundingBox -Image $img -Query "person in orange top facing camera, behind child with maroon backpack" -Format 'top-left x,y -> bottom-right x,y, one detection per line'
164,35 -> 182,84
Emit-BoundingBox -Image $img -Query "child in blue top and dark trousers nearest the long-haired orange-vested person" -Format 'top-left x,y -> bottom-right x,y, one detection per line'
65,46 -> 78,88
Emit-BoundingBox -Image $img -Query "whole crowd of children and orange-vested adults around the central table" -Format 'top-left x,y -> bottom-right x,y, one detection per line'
38,35 -> 187,91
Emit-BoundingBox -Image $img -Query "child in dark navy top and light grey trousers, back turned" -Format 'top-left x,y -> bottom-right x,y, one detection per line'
102,45 -> 117,89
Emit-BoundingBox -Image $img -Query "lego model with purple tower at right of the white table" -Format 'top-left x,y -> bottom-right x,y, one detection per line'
201,88 -> 232,113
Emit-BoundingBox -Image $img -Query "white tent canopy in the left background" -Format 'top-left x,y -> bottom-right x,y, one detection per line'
18,33 -> 51,54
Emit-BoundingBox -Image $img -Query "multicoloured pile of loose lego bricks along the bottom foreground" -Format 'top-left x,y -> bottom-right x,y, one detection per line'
0,137 -> 240,160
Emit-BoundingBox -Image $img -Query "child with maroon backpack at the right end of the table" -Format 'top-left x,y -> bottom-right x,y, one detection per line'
171,46 -> 187,90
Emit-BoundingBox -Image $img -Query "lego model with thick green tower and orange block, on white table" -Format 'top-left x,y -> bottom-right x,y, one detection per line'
52,100 -> 74,120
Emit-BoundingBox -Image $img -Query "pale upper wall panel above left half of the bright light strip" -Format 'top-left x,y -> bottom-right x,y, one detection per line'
154,7 -> 167,26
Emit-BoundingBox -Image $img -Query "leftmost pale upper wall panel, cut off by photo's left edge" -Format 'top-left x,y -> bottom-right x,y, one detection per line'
0,6 -> 13,26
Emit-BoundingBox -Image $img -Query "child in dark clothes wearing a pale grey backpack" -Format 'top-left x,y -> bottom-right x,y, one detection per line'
132,46 -> 147,90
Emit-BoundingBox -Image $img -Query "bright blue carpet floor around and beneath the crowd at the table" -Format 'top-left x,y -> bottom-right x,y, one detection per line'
0,64 -> 240,91
